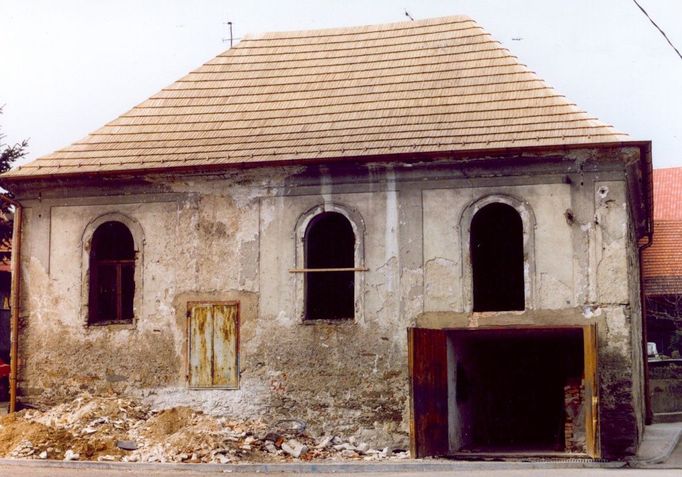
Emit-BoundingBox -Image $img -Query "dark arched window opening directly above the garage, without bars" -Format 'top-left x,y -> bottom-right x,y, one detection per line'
470,203 -> 525,311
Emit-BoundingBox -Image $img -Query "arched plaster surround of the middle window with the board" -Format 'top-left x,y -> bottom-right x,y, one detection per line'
291,203 -> 365,323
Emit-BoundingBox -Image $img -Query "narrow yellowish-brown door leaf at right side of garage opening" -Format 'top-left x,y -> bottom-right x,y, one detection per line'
583,324 -> 601,458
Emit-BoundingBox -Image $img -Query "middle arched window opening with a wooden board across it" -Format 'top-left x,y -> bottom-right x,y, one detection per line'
304,212 -> 355,320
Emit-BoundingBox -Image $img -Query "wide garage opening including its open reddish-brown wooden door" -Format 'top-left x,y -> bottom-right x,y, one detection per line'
411,327 -> 594,456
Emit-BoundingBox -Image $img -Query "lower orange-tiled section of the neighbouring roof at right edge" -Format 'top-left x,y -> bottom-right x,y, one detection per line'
642,221 -> 682,295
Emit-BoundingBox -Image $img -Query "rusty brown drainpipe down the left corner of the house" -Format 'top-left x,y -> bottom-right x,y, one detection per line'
0,194 -> 23,414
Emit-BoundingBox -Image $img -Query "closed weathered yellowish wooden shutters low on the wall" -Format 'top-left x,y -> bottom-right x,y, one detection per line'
188,302 -> 239,389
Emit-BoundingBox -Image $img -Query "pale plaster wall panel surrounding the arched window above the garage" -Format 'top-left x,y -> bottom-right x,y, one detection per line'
423,184 -> 575,311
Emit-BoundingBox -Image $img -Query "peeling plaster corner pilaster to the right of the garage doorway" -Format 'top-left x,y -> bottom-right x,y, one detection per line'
594,181 -> 644,457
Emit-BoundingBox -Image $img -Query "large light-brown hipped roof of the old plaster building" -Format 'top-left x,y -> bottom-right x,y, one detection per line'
7,16 -> 628,178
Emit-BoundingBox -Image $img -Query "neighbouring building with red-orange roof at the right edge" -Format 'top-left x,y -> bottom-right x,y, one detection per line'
642,167 -> 682,357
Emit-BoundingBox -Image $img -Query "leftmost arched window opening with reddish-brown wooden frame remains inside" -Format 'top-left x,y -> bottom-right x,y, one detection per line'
88,221 -> 135,324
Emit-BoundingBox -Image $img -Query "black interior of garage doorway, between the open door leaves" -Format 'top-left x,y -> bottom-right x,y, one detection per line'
450,329 -> 583,452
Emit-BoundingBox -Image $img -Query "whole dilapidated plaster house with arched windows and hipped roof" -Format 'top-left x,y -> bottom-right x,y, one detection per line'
0,17 -> 651,458
